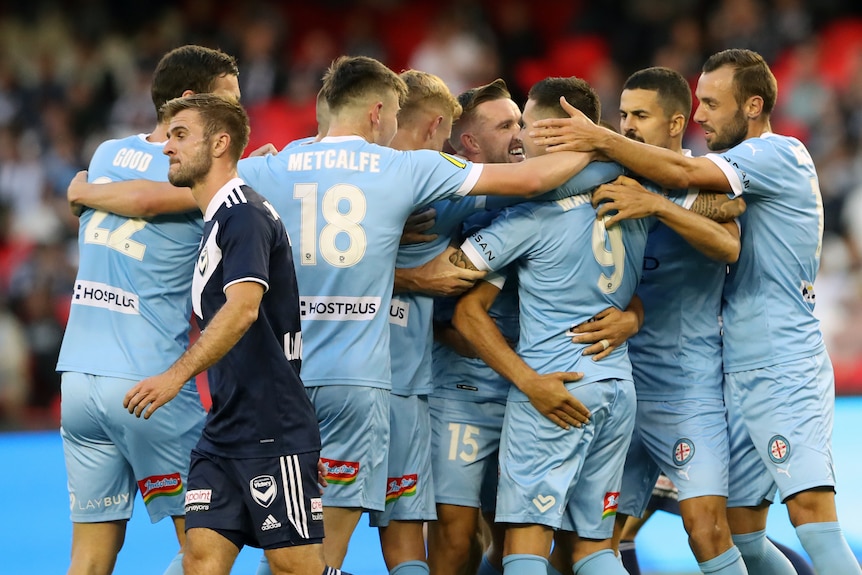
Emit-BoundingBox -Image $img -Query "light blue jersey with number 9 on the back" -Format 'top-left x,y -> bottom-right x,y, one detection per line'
461,169 -> 654,401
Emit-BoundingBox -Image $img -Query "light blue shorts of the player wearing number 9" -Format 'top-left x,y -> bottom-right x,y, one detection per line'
495,379 -> 637,539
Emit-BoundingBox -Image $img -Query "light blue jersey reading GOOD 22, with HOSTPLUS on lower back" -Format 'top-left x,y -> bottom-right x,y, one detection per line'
57,135 -> 203,380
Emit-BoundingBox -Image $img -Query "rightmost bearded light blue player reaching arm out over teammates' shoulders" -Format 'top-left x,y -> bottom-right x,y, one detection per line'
535,49 -> 862,574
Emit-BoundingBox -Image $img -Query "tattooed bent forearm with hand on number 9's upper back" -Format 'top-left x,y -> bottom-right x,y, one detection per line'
593,176 -> 740,263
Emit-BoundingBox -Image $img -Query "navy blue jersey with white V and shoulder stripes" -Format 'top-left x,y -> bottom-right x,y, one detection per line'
192,178 -> 320,458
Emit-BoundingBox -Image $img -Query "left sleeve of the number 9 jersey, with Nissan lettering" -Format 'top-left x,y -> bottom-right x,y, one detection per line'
461,205 -> 540,272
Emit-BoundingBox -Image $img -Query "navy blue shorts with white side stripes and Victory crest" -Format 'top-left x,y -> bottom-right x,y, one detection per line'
185,449 -> 323,549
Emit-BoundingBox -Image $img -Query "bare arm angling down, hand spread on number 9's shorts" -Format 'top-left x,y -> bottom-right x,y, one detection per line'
452,254 -> 590,429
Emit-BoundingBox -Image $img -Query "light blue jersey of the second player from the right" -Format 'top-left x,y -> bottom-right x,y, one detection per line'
628,192 -> 727,401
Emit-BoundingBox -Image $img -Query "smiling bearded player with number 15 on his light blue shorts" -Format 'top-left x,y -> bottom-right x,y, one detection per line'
428,79 -> 524,575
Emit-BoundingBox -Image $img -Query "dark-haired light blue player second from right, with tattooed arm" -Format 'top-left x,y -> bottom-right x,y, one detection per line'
596,68 -> 747,574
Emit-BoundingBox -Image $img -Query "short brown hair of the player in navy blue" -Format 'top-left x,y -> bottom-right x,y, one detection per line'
161,94 -> 251,162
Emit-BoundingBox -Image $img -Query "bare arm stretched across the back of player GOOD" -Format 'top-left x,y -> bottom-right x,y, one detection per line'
66,171 -> 200,218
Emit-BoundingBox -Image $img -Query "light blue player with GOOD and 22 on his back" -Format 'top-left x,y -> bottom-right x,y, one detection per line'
57,46 -> 239,574
